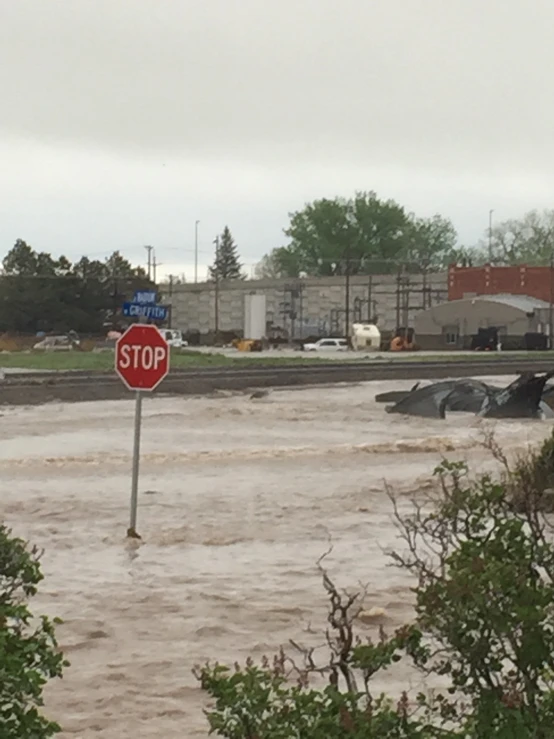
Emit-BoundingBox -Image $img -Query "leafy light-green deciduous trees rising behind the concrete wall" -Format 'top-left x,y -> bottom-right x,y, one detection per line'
257,199 -> 554,277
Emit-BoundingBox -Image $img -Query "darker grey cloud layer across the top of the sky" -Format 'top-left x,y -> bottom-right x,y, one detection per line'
0,0 -> 554,171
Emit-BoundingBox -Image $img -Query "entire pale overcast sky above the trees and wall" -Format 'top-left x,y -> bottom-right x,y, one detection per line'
0,0 -> 554,281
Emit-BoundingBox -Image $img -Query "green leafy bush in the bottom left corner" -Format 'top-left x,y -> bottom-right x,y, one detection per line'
0,525 -> 68,739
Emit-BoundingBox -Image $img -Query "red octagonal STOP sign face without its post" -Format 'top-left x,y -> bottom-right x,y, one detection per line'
115,323 -> 170,390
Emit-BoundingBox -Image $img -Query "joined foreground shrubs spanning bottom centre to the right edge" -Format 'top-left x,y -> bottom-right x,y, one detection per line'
195,454 -> 554,739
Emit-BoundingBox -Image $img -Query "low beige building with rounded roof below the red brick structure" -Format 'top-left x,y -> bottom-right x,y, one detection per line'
415,298 -> 548,349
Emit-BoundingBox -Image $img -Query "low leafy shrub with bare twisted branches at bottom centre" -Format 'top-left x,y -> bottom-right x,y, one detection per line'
195,555 -> 424,739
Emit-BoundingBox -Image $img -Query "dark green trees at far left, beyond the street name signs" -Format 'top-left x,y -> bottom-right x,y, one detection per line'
0,239 -> 152,333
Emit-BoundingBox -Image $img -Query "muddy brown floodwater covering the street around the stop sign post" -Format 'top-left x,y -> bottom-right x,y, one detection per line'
0,377 -> 552,739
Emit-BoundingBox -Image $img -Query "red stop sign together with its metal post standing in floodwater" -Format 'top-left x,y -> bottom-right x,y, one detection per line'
115,323 -> 170,539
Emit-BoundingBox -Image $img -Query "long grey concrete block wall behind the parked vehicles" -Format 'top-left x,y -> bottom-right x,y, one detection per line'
160,273 -> 448,338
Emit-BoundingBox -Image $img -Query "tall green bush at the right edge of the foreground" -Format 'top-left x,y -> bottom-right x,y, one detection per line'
386,462 -> 554,739
